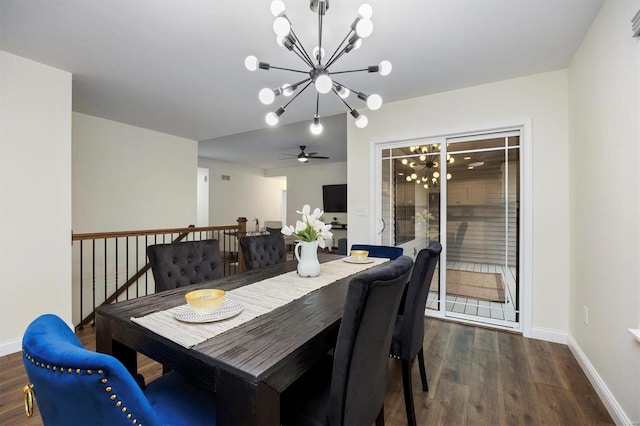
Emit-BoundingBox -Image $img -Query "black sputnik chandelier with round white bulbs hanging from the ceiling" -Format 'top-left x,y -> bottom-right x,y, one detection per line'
244,0 -> 391,135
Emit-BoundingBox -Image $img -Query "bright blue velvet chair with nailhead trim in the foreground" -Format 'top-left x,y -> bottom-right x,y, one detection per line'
22,314 -> 216,426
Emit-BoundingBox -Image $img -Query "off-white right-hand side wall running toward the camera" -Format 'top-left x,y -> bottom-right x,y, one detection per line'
569,0 -> 640,424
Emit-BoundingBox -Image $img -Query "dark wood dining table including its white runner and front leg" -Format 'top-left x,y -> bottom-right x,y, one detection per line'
95,253 -> 388,426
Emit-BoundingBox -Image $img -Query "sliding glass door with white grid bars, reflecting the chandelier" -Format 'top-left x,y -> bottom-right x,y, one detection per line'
378,131 -> 521,328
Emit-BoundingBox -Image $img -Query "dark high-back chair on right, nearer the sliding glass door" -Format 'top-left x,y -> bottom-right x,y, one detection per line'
389,241 -> 442,426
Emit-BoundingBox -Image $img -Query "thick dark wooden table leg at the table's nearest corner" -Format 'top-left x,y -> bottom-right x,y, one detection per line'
216,369 -> 280,426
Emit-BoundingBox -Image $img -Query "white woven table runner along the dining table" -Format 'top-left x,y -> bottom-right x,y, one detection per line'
131,258 -> 389,348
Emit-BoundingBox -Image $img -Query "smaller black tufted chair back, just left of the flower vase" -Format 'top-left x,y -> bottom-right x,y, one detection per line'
240,232 -> 287,271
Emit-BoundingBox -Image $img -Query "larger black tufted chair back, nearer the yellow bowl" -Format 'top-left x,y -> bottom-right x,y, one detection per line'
147,240 -> 223,292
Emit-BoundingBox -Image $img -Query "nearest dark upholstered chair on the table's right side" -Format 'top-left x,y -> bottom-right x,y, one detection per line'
281,256 -> 413,426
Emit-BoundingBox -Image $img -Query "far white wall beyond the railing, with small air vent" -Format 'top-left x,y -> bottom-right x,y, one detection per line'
198,157 -> 287,229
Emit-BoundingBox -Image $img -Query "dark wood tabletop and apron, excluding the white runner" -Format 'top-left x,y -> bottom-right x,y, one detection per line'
96,254 -> 351,393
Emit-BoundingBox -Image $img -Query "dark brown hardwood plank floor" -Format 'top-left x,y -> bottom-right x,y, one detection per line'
0,319 -> 614,426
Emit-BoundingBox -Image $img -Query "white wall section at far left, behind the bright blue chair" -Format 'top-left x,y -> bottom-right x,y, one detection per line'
0,51 -> 71,356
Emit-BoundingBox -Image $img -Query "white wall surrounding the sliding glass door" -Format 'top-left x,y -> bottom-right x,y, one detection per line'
347,70 -> 569,336
